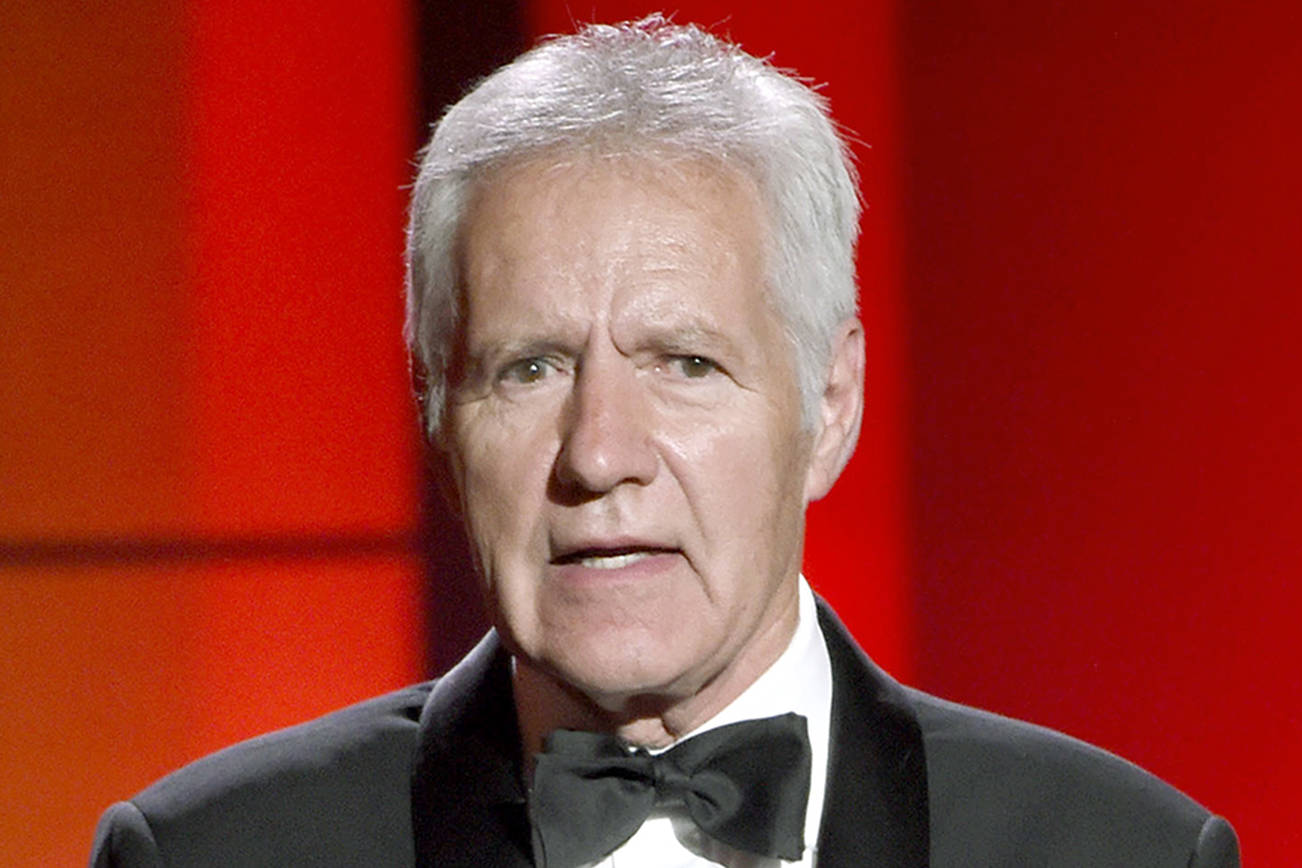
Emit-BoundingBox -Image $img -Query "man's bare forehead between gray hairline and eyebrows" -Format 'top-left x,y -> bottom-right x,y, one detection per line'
461,154 -> 767,308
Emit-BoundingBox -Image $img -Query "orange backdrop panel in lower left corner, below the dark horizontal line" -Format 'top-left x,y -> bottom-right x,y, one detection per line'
0,567 -> 198,867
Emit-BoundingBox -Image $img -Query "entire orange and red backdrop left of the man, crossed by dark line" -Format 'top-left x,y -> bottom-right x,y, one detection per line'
0,3 -> 424,865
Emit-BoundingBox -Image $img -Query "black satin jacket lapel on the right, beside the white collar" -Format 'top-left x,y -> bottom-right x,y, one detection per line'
818,600 -> 930,868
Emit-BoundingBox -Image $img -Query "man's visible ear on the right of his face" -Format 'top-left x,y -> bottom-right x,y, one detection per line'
805,318 -> 863,502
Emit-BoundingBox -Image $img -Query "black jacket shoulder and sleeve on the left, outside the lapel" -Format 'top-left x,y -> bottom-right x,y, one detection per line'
91,683 -> 431,865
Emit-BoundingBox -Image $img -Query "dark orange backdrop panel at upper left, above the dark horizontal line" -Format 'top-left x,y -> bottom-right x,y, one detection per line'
0,0 -> 187,540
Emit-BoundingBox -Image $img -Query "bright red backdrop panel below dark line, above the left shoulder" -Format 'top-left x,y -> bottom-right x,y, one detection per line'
175,556 -> 423,765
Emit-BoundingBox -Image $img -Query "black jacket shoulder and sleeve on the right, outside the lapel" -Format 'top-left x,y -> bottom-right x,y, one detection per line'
906,688 -> 1238,868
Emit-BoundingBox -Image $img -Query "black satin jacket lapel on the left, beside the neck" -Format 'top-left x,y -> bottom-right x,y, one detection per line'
411,632 -> 533,868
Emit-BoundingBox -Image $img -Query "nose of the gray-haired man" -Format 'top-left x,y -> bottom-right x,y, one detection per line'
556,355 -> 659,500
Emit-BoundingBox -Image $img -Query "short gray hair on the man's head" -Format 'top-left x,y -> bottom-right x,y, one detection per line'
406,14 -> 859,435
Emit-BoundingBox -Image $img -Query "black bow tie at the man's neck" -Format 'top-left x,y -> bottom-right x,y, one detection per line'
529,714 -> 810,868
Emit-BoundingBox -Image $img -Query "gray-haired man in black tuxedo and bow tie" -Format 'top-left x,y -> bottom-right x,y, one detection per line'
92,17 -> 1238,868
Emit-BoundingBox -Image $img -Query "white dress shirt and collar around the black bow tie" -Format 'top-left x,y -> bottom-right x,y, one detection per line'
590,576 -> 832,868
